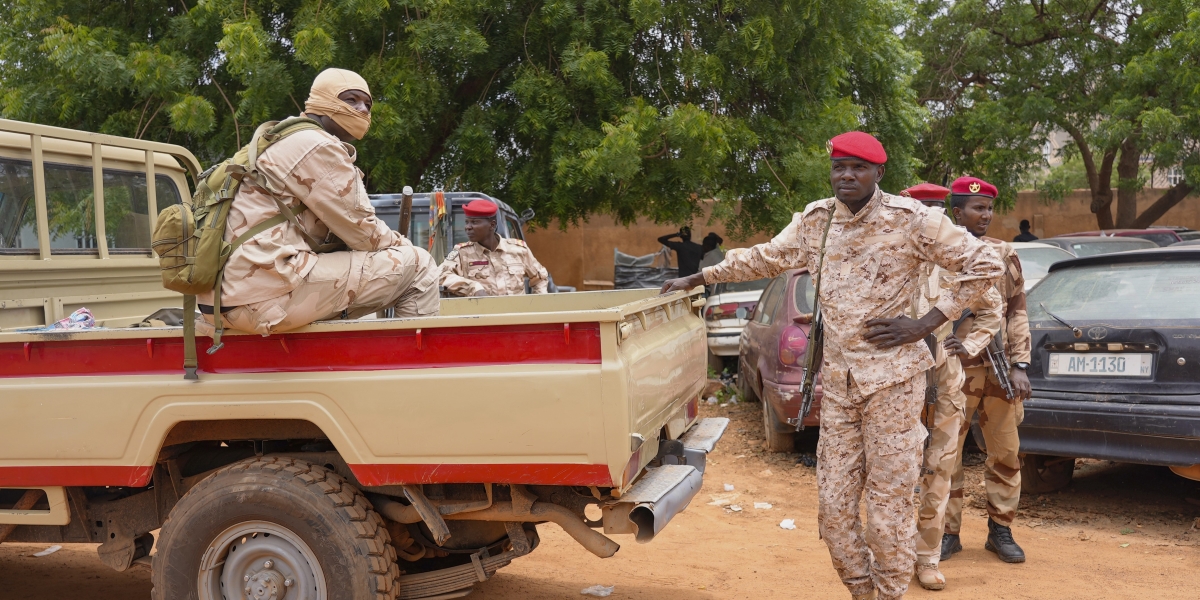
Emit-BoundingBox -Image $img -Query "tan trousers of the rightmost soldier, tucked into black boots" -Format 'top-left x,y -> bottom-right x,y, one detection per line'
946,365 -> 1025,534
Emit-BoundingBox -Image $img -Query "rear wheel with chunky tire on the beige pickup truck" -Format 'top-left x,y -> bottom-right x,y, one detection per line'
151,456 -> 400,600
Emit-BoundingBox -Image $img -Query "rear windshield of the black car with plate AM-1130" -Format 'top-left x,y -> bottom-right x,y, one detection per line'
1027,260 -> 1200,326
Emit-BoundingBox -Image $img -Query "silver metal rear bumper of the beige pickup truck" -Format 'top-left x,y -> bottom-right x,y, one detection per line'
602,418 -> 730,544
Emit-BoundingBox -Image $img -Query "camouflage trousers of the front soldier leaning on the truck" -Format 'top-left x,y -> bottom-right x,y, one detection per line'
817,373 -> 925,600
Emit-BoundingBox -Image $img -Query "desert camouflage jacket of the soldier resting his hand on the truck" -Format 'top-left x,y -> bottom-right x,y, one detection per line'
703,190 -> 1003,395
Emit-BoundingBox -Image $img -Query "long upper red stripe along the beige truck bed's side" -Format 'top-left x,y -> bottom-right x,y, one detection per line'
0,323 -> 600,378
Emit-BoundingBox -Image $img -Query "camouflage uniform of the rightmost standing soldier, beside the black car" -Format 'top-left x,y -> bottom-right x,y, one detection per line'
946,238 -> 1030,534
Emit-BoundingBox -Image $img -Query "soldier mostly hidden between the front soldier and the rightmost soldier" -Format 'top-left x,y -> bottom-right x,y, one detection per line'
900,184 -> 1003,589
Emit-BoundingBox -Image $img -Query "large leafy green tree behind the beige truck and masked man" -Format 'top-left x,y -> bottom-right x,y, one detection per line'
0,0 -> 922,235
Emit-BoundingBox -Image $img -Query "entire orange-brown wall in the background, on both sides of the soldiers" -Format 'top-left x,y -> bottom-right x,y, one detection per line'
526,190 -> 1200,290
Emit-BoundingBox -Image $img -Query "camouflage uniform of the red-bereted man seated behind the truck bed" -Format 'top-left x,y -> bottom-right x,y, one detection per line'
442,238 -> 550,296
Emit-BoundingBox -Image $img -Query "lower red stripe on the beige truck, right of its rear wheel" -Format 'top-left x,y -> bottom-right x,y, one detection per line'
350,464 -> 613,486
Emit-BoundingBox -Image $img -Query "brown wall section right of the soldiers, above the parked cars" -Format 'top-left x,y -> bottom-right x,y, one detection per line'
988,190 -> 1200,241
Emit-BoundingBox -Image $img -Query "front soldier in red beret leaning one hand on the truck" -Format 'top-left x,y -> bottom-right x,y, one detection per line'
662,132 -> 1003,599
